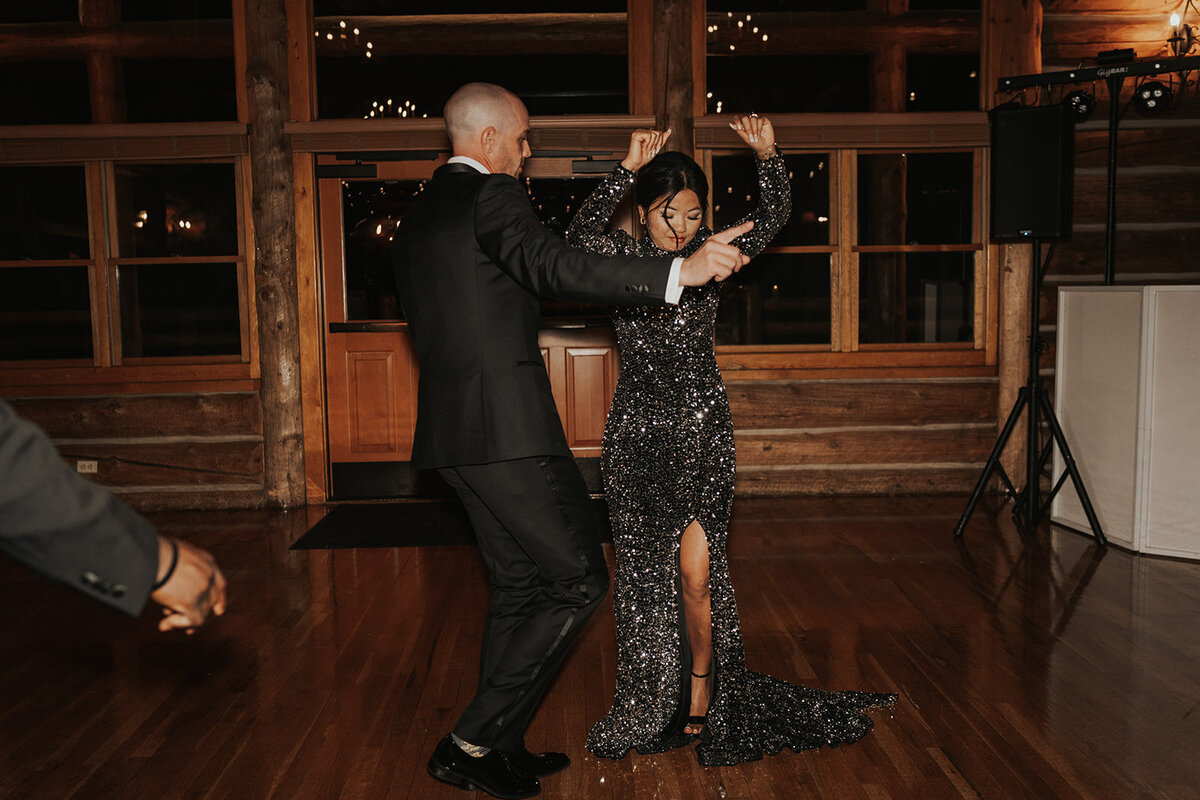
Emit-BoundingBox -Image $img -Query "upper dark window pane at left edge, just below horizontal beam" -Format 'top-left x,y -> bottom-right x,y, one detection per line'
0,167 -> 90,260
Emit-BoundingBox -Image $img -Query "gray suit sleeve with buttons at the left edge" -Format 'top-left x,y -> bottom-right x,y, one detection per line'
0,401 -> 158,616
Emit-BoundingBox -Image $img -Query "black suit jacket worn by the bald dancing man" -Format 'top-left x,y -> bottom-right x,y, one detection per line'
392,164 -> 671,468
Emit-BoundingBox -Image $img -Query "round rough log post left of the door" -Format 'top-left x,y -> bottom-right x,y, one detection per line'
235,0 -> 305,509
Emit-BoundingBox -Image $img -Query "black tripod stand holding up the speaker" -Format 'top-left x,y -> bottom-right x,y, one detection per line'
954,237 -> 1108,547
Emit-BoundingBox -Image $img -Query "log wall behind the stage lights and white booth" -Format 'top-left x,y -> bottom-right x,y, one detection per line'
1039,0 -> 1200,387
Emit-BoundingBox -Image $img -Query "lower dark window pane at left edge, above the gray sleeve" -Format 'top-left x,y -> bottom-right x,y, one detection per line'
0,266 -> 91,361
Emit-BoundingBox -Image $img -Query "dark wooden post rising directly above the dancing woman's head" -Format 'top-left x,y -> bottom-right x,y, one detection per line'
652,0 -> 706,156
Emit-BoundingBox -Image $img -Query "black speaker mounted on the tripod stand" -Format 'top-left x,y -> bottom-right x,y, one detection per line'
988,103 -> 1075,241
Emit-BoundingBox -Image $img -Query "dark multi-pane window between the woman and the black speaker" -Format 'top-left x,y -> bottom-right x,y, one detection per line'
704,135 -> 988,359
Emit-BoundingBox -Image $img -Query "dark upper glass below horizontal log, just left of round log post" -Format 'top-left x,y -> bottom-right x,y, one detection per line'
125,58 -> 238,122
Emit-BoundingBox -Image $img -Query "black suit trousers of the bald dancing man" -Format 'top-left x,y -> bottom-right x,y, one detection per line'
438,456 -> 608,751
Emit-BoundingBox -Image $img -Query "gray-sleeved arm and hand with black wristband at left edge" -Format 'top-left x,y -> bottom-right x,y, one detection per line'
0,401 -> 226,632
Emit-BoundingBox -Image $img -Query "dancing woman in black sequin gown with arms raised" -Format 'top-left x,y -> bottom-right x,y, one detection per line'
568,116 -> 895,765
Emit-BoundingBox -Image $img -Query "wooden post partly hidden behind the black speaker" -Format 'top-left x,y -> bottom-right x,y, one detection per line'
979,0 -> 1042,475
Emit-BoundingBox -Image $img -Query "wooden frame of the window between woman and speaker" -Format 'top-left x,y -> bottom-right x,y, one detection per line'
696,112 -> 1000,379
